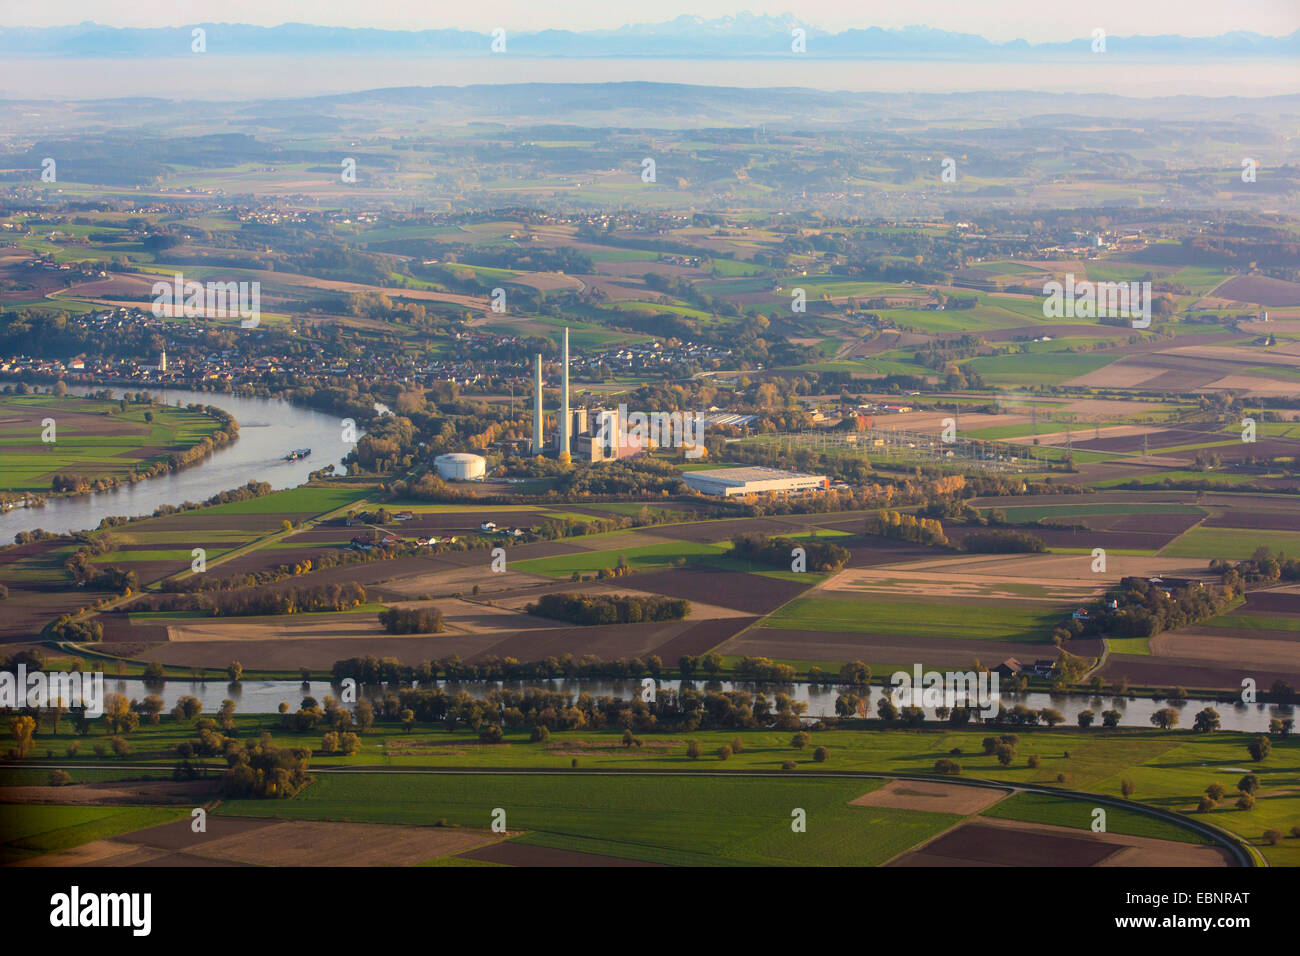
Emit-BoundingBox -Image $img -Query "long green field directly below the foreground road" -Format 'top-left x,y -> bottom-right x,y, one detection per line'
220,775 -> 961,866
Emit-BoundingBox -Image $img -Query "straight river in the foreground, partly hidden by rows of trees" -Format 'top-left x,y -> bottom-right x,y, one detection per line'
94,675 -> 1294,734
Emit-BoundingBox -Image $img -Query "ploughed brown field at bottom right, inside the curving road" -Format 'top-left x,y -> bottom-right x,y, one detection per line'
885,817 -> 1230,866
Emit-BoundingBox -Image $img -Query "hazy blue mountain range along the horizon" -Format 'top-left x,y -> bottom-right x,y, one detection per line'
0,13 -> 1300,60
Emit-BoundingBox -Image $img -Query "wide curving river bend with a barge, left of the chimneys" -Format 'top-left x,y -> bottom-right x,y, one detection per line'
0,385 -> 354,542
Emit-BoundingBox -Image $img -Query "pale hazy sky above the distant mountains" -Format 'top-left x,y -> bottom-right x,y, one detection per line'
10,0 -> 1300,42
